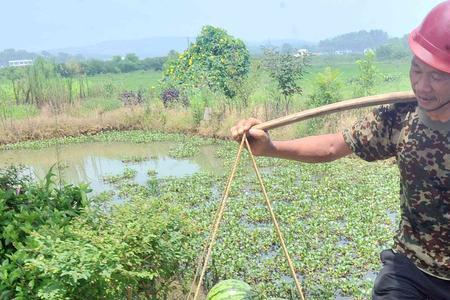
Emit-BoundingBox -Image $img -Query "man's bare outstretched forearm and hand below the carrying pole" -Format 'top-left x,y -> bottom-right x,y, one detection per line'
231,119 -> 352,163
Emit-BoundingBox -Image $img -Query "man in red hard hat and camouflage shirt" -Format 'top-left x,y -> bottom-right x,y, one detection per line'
231,0 -> 450,300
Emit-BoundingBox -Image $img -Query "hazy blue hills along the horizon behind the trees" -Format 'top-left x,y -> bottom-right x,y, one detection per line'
0,30 -> 404,65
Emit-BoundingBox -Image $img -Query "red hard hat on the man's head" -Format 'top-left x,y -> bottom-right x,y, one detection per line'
409,0 -> 450,73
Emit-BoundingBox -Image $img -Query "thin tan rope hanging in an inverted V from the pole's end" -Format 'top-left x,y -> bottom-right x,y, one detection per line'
187,134 -> 305,300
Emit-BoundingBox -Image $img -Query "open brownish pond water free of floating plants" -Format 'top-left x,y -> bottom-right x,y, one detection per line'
0,142 -> 223,194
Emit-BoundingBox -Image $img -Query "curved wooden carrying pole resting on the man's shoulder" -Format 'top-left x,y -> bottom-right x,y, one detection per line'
253,91 -> 417,130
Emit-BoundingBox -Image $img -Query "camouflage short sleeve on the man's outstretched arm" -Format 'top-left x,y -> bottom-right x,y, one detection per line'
343,106 -> 397,161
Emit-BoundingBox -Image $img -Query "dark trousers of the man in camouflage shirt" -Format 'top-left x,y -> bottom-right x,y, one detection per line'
372,250 -> 450,300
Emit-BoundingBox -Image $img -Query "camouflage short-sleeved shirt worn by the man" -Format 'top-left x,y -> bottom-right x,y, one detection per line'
343,103 -> 450,280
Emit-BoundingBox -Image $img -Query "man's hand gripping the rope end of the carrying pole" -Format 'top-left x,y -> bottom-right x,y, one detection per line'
231,118 -> 275,156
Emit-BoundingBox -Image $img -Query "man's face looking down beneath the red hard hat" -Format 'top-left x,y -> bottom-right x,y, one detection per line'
409,57 -> 450,116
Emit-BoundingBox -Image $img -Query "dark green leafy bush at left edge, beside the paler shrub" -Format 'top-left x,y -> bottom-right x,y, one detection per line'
0,167 -> 88,299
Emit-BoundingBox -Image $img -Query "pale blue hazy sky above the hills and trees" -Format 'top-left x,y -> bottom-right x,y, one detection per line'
0,0 -> 442,51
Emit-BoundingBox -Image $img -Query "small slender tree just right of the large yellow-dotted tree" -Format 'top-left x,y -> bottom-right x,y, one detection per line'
263,48 -> 307,114
